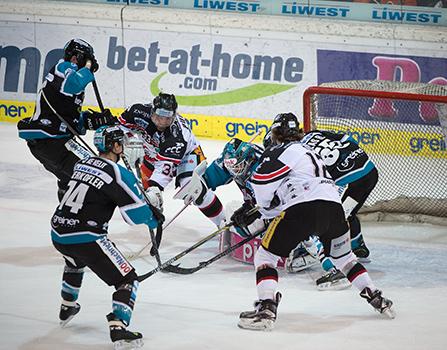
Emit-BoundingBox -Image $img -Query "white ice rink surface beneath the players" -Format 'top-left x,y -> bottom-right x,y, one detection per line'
0,124 -> 447,350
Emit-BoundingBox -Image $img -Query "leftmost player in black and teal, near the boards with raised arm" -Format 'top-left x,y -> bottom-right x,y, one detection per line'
18,39 -> 116,199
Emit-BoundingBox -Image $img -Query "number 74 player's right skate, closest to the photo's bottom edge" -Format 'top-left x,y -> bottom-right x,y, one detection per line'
107,313 -> 143,350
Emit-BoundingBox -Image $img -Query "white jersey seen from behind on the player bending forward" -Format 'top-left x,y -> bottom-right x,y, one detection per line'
250,142 -> 340,219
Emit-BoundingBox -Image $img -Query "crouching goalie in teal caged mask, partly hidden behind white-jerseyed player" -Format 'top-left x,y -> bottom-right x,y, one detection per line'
178,138 -> 350,290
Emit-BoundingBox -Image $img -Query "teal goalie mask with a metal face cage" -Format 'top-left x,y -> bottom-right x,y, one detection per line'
223,138 -> 259,183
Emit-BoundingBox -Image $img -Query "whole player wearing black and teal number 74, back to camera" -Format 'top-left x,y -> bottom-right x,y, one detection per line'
51,126 -> 158,349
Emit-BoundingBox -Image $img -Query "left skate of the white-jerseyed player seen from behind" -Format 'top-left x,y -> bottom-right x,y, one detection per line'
238,292 -> 281,331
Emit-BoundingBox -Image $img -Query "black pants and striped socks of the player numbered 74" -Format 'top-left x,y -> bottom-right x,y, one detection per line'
53,237 -> 138,326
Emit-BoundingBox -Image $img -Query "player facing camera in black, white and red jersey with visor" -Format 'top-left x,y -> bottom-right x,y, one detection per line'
118,93 -> 225,225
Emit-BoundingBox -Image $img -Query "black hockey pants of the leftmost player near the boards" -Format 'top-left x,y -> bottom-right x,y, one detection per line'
27,138 -> 91,200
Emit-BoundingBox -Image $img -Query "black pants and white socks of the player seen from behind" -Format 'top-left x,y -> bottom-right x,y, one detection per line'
254,200 -> 375,299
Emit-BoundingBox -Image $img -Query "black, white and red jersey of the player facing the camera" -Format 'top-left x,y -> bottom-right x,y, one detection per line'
118,104 -> 200,188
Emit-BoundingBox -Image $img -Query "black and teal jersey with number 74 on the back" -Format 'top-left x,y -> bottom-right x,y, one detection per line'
51,157 -> 157,244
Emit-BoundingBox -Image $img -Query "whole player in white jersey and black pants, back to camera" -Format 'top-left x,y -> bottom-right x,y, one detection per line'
238,114 -> 394,330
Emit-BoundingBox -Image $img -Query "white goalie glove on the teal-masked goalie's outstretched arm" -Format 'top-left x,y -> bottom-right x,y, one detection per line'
174,160 -> 208,205
